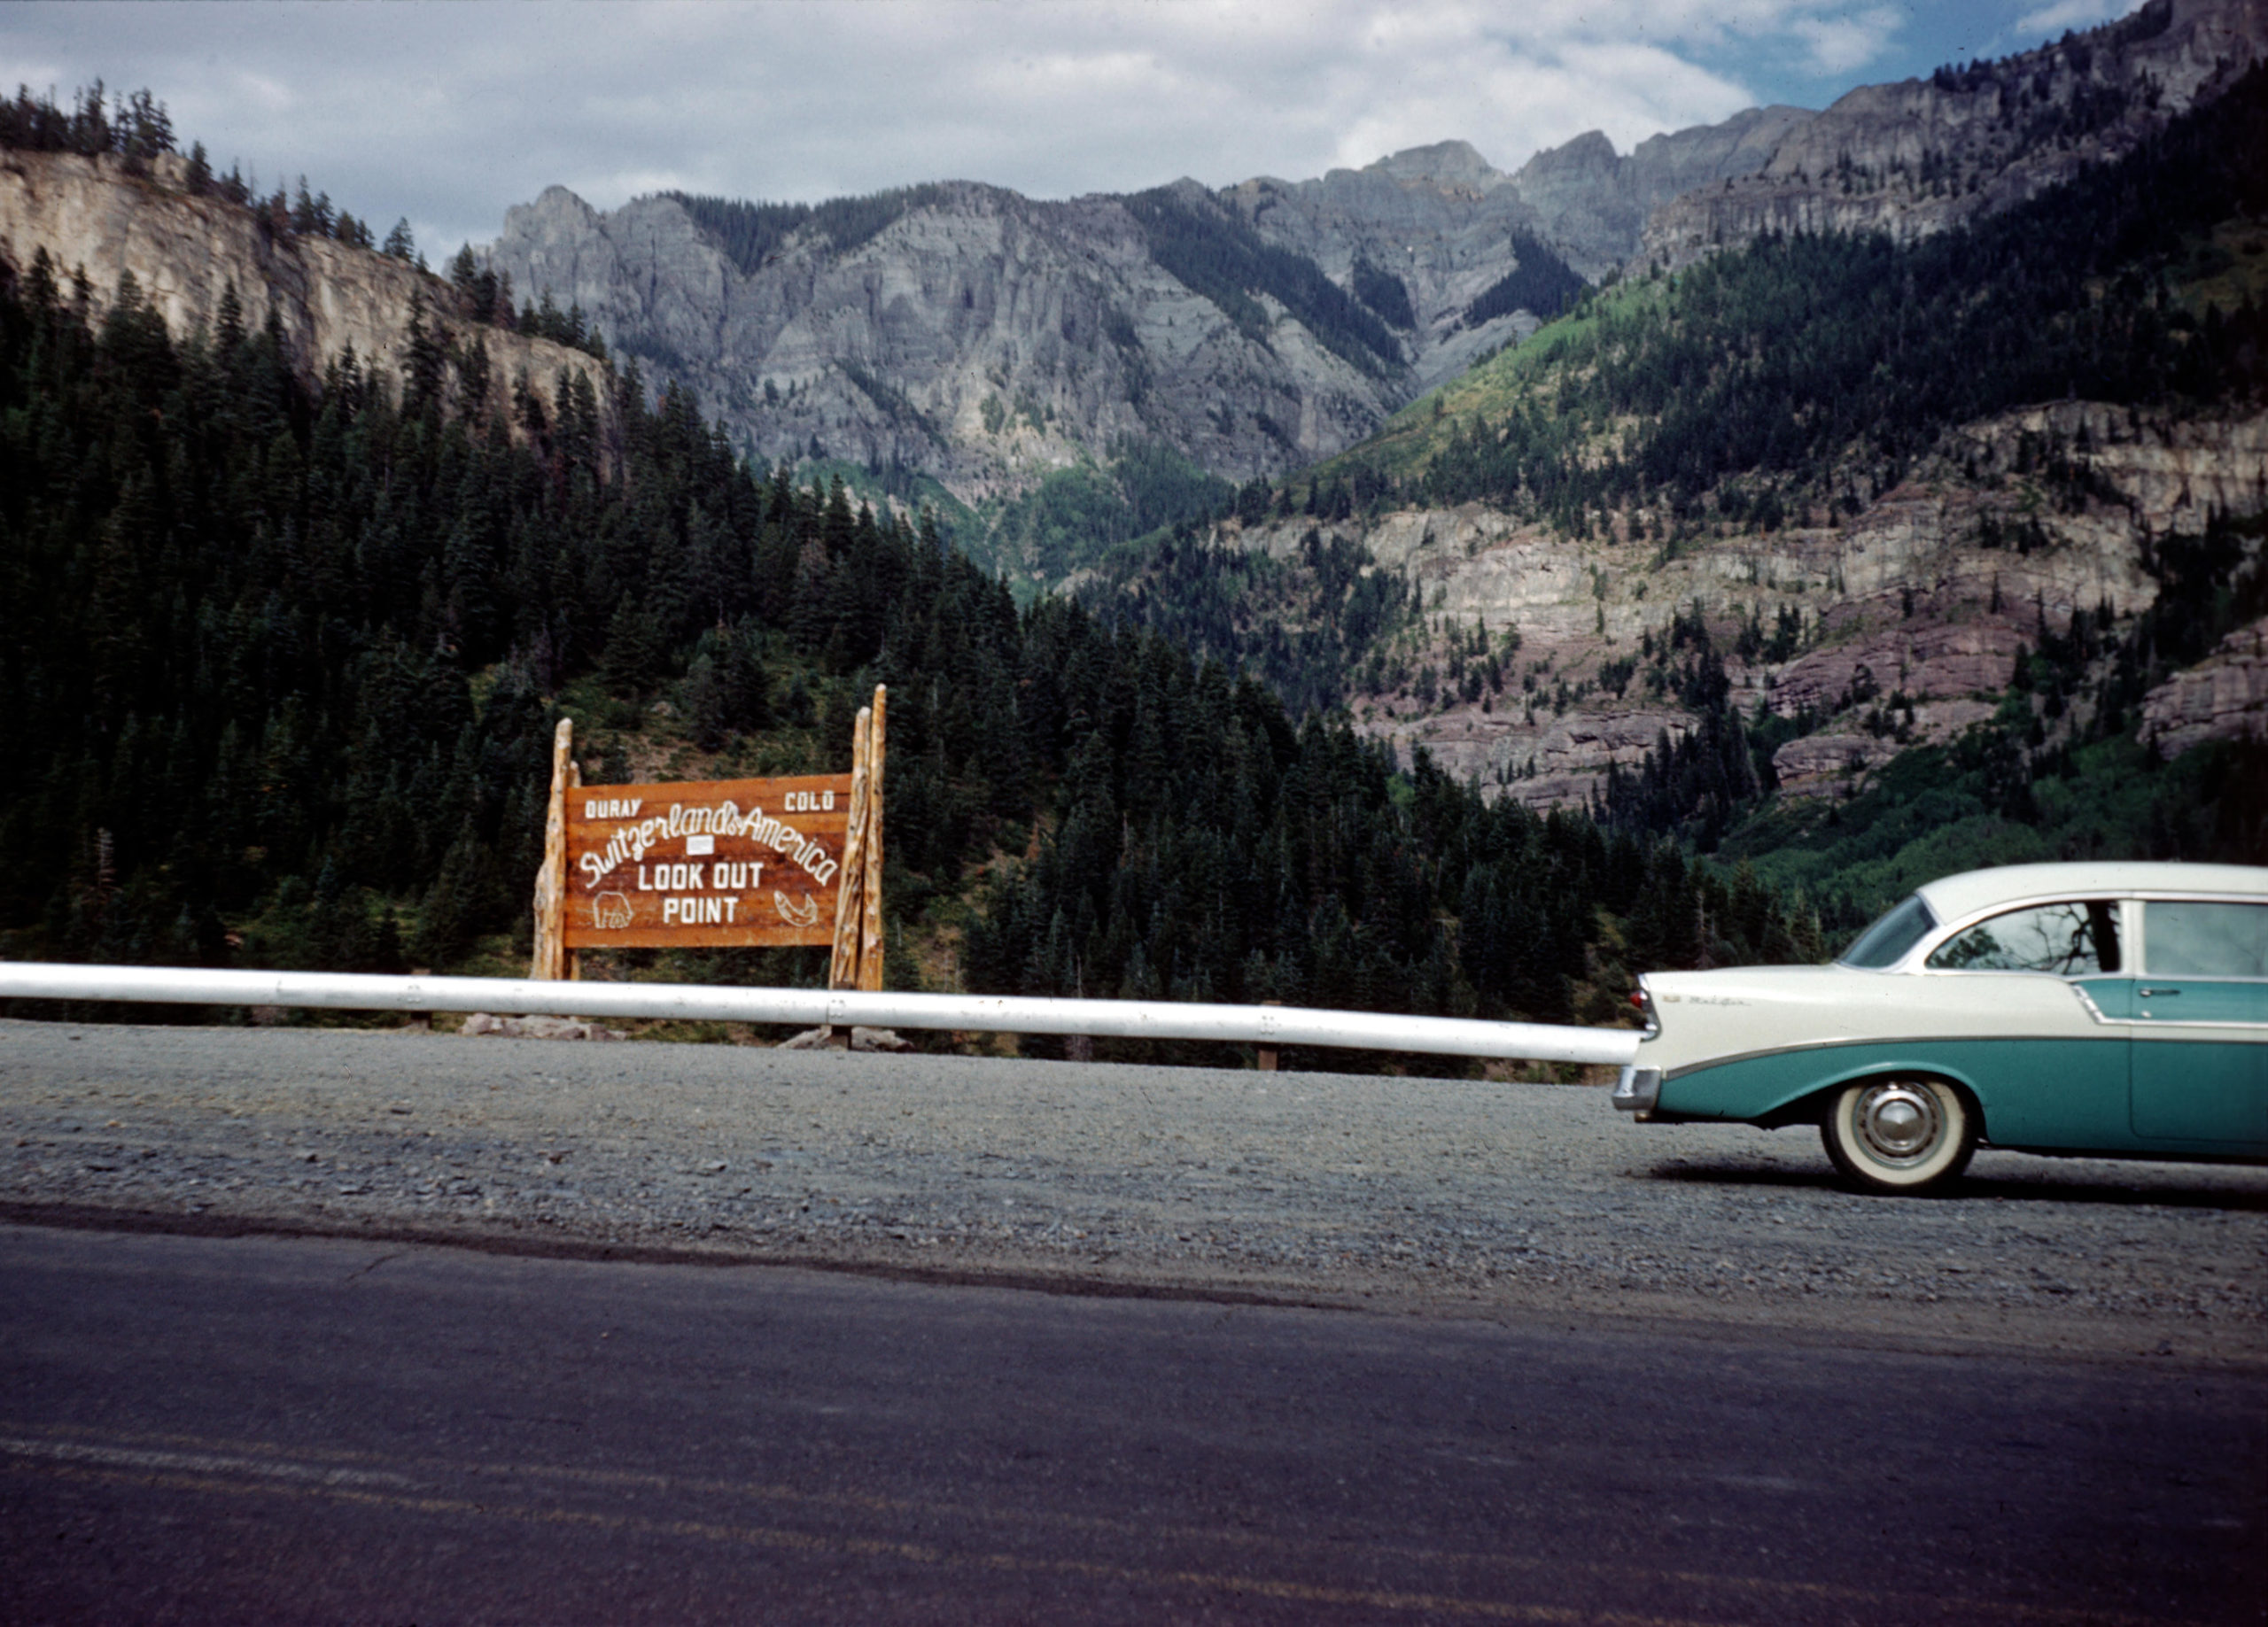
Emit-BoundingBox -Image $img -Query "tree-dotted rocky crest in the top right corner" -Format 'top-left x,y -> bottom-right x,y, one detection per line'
1637,0 -> 2268,269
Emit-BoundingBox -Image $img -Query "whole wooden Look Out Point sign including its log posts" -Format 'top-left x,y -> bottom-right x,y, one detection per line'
528,686 -> 887,988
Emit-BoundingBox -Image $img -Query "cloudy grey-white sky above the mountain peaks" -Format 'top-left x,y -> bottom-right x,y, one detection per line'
0,0 -> 2139,252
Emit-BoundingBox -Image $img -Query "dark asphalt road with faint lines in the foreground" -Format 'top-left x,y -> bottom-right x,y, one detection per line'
0,1226 -> 2268,1623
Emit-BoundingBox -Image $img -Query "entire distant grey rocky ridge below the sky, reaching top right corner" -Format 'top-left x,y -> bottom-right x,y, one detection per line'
469,0 -> 2268,518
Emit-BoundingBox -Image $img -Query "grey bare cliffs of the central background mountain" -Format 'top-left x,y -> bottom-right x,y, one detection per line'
485,120 -> 1806,500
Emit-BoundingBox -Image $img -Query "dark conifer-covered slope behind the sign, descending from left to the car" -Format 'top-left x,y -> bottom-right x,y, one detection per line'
0,188 -> 1817,1069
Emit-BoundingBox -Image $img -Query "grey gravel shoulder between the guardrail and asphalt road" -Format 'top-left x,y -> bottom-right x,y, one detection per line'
0,1022 -> 2268,1367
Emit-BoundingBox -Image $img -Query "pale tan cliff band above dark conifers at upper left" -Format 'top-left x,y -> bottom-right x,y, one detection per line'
0,150 -> 612,432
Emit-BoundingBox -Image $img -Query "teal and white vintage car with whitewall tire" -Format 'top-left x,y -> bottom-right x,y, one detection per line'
1615,864 -> 2268,1192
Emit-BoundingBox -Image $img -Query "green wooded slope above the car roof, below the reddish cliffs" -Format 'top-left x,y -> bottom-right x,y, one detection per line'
1596,516 -> 2268,936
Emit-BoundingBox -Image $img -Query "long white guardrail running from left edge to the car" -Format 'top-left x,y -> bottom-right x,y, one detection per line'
0,961 -> 1637,1065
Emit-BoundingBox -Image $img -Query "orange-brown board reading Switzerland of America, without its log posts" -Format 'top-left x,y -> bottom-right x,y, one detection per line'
563,775 -> 850,949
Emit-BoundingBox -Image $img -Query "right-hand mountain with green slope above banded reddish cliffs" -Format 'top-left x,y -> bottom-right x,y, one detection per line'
1089,56 -> 2268,807
